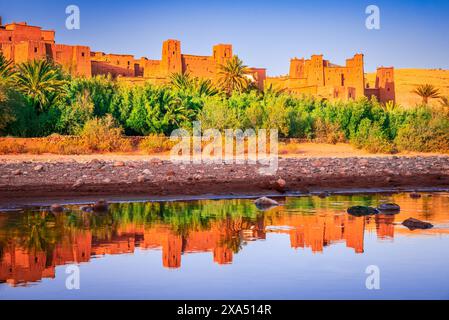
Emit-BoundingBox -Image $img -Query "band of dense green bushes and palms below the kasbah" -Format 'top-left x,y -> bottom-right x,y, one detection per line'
0,55 -> 449,152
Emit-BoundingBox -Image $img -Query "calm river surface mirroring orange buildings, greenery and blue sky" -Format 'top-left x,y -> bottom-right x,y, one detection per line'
0,193 -> 449,299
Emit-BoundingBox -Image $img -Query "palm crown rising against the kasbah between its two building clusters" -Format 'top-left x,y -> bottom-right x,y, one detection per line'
218,56 -> 251,95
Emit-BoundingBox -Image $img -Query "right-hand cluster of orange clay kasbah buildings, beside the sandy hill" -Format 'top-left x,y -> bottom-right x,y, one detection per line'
265,54 -> 395,102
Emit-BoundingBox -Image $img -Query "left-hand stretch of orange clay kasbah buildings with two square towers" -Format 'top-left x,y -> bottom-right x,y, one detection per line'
0,18 -> 266,89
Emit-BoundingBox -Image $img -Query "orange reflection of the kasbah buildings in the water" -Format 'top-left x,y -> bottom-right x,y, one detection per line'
0,195 -> 448,286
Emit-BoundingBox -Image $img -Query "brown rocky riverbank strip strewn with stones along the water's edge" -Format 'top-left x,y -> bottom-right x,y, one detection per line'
0,156 -> 449,203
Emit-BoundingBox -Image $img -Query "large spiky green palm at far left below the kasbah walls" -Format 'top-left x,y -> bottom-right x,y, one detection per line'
15,60 -> 66,111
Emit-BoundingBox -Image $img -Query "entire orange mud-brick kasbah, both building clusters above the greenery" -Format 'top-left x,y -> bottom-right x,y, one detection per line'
0,17 -> 395,103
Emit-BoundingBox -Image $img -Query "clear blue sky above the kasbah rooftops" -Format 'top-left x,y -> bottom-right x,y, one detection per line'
0,0 -> 449,75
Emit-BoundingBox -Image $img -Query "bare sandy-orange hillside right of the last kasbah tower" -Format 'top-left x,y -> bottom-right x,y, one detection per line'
366,69 -> 449,106
